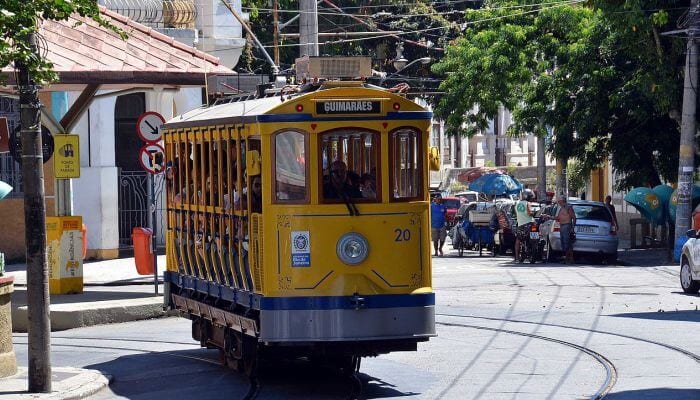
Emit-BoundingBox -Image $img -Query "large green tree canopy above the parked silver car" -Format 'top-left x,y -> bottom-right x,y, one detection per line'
433,0 -> 687,188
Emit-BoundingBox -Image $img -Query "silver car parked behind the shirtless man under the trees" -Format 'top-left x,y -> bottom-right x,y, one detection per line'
540,200 -> 619,263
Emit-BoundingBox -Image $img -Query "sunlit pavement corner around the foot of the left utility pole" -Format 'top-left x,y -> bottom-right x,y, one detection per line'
0,367 -> 112,400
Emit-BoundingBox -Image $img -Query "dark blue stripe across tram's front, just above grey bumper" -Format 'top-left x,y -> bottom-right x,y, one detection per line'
260,293 -> 435,310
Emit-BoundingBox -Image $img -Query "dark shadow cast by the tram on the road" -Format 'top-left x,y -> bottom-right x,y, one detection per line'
86,349 -> 418,400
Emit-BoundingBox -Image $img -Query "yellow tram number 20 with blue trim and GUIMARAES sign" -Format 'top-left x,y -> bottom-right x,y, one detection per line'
163,77 -> 435,373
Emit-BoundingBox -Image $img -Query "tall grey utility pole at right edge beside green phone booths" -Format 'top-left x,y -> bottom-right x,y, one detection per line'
675,0 -> 700,239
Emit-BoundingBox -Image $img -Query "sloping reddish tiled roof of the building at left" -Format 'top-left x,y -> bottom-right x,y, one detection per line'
4,7 -> 234,84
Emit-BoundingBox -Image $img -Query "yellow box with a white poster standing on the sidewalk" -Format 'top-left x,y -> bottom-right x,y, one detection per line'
46,217 -> 83,294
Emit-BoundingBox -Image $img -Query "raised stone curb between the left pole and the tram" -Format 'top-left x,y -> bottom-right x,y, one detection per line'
12,296 -> 177,332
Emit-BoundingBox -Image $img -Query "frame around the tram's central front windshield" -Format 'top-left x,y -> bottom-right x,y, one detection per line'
317,126 -> 383,204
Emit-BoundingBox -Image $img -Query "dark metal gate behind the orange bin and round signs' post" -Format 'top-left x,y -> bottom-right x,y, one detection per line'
118,170 -> 165,248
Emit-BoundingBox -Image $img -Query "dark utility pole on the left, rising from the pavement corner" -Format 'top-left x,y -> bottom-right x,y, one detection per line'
16,33 -> 51,393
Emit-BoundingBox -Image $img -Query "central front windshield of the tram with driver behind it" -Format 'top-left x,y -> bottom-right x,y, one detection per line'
320,128 -> 381,202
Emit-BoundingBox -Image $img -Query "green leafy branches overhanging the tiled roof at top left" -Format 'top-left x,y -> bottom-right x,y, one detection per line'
0,0 -> 120,83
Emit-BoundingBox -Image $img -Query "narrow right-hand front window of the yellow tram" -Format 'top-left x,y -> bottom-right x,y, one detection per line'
389,129 -> 423,201
